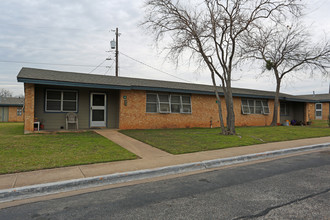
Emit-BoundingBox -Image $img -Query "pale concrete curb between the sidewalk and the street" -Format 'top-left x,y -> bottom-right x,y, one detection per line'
0,143 -> 330,203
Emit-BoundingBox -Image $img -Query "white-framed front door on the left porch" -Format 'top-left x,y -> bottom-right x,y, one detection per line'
90,93 -> 107,127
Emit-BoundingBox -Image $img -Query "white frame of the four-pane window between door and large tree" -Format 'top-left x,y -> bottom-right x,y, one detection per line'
146,92 -> 192,114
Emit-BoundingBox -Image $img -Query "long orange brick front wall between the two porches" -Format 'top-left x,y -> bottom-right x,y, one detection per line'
119,90 -> 273,129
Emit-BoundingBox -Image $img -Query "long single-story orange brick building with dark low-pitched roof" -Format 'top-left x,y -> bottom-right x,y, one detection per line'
17,68 -> 330,132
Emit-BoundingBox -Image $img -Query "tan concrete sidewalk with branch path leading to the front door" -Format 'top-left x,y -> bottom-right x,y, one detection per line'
0,129 -> 330,189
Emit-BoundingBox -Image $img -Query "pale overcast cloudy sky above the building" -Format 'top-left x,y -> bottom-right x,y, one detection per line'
0,0 -> 330,96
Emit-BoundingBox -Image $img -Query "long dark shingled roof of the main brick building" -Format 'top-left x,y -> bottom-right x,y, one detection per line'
17,67 -> 324,102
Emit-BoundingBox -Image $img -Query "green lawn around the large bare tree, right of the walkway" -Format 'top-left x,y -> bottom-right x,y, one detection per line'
120,126 -> 330,154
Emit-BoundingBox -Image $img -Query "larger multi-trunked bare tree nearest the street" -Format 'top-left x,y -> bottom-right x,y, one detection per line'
143,0 -> 301,134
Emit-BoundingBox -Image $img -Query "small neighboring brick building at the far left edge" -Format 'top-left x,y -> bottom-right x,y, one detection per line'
0,97 -> 24,122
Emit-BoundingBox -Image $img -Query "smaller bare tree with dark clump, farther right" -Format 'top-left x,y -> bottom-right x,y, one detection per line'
245,20 -> 330,126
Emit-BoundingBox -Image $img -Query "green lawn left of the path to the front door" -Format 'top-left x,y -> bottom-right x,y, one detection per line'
0,123 -> 137,174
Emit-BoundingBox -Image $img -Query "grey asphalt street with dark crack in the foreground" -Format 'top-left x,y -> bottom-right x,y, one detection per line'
0,150 -> 330,220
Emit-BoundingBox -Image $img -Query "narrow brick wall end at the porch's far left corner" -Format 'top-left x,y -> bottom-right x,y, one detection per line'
24,83 -> 35,133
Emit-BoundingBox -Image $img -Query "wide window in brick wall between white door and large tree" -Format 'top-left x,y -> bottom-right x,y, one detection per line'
146,93 -> 191,113
